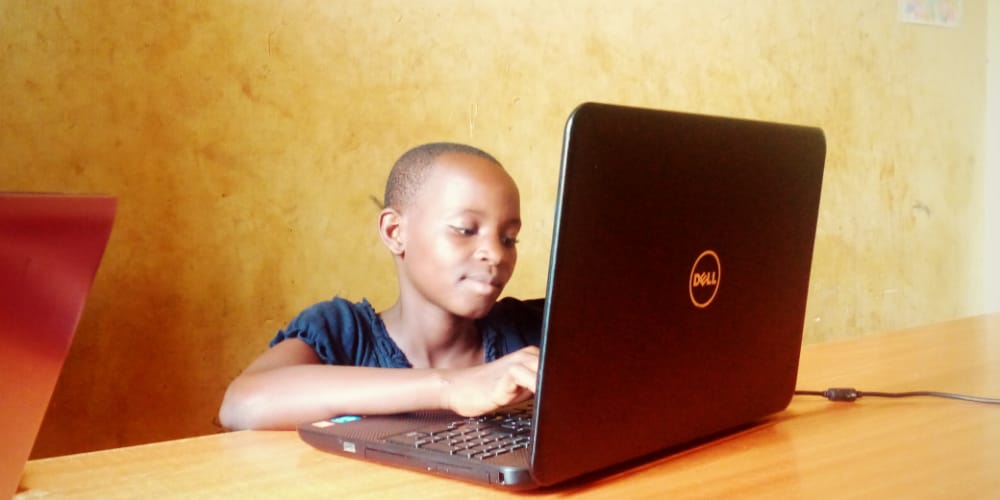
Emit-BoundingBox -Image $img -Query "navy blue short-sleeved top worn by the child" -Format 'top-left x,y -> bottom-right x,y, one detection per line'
271,297 -> 545,368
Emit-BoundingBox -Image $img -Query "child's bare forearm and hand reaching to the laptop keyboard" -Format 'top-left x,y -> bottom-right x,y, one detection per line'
219,339 -> 538,429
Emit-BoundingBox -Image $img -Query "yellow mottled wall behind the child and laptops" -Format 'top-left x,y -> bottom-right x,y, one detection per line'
0,0 -> 986,456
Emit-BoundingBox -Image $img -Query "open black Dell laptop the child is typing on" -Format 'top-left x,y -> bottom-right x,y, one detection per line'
298,103 -> 826,489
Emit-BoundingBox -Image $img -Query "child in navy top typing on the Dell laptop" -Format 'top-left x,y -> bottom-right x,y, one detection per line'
219,143 -> 541,429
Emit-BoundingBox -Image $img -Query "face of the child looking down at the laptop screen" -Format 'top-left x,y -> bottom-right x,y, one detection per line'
401,153 -> 521,318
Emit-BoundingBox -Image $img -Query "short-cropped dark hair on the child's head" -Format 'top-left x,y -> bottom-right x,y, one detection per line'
383,142 -> 502,210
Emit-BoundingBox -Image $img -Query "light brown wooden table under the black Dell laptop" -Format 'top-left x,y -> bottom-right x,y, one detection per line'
17,314 -> 1000,498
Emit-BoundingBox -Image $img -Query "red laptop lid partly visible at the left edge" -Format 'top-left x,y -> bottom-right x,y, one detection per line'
0,192 -> 116,498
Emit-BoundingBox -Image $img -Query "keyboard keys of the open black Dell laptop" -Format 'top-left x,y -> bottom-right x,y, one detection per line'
387,406 -> 532,460
